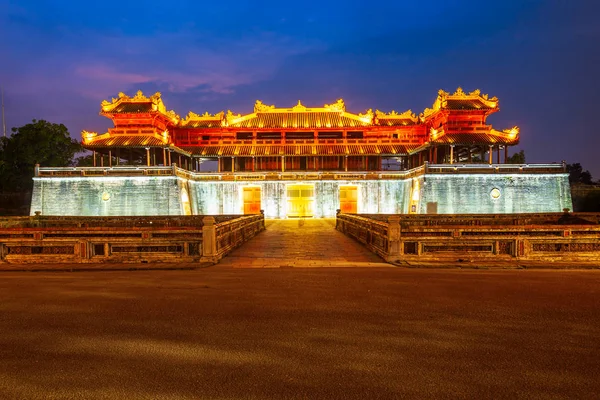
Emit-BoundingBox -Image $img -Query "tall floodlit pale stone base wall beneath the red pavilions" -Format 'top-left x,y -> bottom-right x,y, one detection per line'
31,164 -> 573,218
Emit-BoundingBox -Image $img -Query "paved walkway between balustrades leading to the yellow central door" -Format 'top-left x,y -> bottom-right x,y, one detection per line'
219,219 -> 390,268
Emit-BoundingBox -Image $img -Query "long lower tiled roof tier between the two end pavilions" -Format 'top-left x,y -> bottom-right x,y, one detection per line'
183,144 -> 417,157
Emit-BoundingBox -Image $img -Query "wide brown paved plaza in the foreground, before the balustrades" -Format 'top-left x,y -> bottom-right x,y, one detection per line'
0,266 -> 600,399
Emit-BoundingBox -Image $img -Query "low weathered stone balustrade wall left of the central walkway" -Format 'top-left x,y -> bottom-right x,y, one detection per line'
0,214 -> 264,269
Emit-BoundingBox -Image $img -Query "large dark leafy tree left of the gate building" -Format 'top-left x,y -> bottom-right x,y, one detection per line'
0,119 -> 83,192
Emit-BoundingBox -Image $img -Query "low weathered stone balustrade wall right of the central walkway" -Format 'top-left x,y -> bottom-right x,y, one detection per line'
336,213 -> 600,266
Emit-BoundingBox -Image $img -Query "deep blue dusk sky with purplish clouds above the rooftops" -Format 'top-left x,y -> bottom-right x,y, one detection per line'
0,0 -> 600,179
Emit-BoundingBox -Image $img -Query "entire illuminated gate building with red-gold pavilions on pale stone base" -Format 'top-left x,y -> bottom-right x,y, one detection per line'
31,88 -> 572,218
